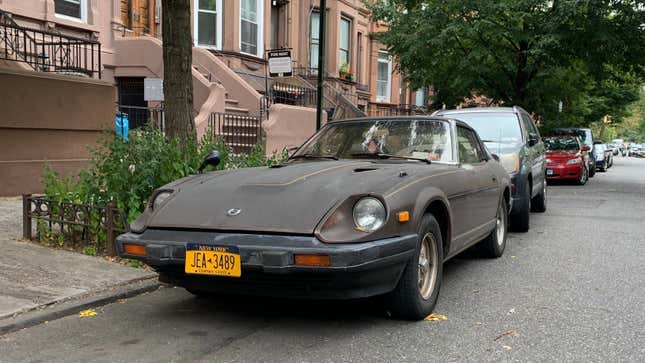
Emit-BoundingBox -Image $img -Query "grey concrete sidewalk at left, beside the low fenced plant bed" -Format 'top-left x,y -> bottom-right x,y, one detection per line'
0,198 -> 158,331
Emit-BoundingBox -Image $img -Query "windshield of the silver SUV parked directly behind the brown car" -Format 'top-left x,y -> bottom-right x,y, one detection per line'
445,112 -> 522,143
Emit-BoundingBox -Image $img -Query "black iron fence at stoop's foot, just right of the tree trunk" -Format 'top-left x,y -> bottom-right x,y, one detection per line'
208,112 -> 262,153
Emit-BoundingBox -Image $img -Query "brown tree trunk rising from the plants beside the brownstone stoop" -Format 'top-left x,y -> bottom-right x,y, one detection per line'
161,0 -> 197,143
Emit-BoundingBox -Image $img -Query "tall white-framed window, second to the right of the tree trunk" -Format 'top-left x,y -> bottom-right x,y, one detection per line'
240,0 -> 264,57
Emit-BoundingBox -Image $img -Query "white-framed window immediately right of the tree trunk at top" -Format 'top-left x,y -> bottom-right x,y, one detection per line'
195,0 -> 222,49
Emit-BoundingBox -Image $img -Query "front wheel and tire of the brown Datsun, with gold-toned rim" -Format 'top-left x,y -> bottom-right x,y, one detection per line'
387,214 -> 443,320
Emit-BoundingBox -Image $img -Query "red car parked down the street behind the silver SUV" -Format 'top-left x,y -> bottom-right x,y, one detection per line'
544,136 -> 589,185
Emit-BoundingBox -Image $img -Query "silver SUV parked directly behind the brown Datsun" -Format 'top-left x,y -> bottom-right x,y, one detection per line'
434,107 -> 547,232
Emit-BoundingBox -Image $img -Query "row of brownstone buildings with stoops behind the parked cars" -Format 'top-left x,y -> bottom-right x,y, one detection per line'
0,0 -> 426,195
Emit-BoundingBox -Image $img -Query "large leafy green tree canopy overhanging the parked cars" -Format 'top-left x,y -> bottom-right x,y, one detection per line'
367,0 -> 645,125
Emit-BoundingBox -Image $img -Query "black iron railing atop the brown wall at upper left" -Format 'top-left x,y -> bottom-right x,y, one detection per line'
0,11 -> 101,78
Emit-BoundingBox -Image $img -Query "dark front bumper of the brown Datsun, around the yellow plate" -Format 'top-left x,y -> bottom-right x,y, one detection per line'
117,230 -> 418,299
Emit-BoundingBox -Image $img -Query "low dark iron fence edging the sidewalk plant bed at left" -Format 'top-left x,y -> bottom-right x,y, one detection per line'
22,194 -> 129,256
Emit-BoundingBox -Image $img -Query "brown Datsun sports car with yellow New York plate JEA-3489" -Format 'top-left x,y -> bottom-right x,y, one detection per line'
118,117 -> 510,319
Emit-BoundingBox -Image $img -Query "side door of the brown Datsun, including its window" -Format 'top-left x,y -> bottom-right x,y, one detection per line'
449,125 -> 499,249
